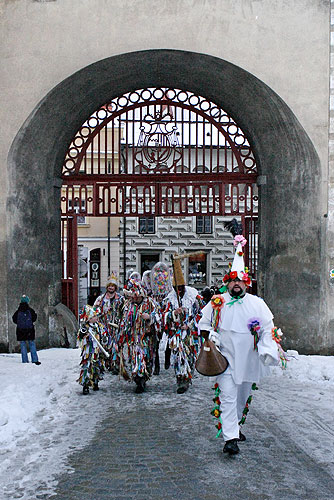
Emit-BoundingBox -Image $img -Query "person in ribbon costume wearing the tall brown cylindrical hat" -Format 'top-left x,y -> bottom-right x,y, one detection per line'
163,252 -> 204,394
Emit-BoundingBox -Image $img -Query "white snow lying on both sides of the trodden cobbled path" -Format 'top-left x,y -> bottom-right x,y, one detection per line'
0,349 -> 334,500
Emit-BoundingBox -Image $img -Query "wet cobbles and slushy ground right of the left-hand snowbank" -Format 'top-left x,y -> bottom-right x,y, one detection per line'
41,369 -> 334,500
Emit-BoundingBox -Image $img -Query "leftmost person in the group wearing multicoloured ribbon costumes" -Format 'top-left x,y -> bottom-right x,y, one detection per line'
77,305 -> 109,395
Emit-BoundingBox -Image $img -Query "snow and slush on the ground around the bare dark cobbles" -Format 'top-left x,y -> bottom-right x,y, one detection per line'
0,349 -> 334,500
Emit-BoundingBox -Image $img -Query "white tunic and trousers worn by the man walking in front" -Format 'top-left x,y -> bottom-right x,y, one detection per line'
199,292 -> 279,441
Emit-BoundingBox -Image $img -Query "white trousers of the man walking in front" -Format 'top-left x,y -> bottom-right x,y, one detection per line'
216,373 -> 252,441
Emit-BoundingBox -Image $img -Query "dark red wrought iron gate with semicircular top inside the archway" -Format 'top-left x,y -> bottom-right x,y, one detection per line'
61,88 -> 258,310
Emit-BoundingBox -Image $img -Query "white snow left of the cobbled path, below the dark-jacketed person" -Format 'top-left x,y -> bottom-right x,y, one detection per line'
0,349 -> 112,500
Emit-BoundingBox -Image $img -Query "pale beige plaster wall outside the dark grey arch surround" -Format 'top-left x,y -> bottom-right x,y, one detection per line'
0,0 -> 328,348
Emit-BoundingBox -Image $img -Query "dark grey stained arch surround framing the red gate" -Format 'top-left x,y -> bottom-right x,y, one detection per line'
7,50 -> 321,352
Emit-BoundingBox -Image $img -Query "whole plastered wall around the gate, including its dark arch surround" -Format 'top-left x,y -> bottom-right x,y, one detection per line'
0,0 -> 333,351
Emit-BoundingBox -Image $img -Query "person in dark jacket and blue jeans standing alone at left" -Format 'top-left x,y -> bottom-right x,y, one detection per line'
12,295 -> 41,365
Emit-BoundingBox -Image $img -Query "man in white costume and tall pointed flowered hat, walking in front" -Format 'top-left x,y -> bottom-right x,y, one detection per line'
199,219 -> 288,455
